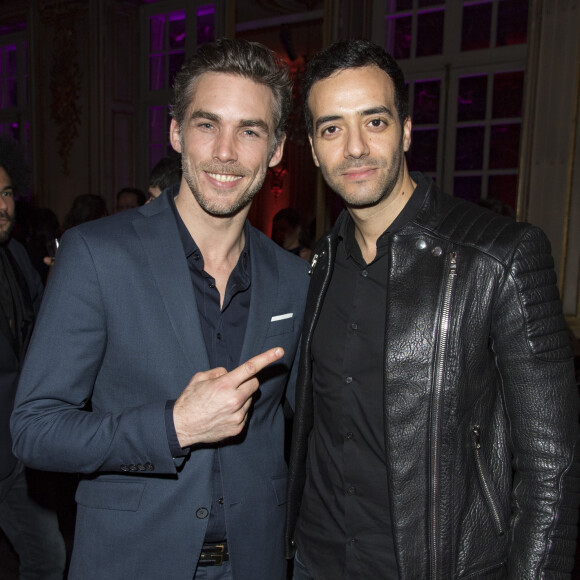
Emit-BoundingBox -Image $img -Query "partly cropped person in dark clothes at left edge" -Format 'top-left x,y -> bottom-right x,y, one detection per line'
0,135 -> 66,580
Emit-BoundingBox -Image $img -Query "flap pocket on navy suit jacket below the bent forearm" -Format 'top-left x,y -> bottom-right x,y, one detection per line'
75,480 -> 145,512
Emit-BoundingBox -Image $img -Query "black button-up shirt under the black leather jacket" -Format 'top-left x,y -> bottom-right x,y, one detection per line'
296,182 -> 425,580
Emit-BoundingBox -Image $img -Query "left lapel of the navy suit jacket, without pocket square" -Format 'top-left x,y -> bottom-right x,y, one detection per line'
133,194 -> 209,370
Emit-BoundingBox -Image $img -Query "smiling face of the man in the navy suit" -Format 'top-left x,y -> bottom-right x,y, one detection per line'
170,72 -> 284,216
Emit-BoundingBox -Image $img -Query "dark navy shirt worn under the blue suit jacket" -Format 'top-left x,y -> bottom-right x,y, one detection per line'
165,187 -> 251,542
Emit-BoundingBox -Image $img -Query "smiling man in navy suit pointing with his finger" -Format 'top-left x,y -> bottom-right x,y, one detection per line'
12,40 -> 308,580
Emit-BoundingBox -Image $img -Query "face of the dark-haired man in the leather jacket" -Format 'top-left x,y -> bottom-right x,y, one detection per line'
308,66 -> 411,208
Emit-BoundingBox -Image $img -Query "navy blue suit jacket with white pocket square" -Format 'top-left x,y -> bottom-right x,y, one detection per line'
12,194 -> 308,580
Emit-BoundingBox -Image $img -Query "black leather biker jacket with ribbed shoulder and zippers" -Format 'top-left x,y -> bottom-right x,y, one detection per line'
286,174 -> 579,580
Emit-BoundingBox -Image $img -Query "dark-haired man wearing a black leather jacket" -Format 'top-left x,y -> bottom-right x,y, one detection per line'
287,41 -> 578,580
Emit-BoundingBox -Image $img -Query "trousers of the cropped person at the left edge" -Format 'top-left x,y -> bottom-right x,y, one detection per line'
0,461 -> 66,580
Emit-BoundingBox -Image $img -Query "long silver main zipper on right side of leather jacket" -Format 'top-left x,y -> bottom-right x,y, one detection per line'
430,252 -> 457,580
